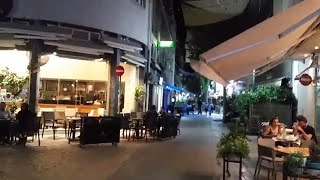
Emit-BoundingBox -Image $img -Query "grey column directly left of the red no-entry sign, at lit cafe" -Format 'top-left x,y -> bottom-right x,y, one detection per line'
109,48 -> 121,116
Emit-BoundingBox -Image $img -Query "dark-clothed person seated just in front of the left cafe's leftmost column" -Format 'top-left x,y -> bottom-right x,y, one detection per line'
16,103 -> 36,144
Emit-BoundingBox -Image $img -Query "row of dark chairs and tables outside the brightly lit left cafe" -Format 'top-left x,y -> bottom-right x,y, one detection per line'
0,108 -> 181,146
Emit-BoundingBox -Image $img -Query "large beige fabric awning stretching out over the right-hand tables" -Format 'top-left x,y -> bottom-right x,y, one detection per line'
191,0 -> 320,86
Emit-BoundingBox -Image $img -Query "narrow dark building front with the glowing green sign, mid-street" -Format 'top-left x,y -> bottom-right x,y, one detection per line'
147,0 -> 177,110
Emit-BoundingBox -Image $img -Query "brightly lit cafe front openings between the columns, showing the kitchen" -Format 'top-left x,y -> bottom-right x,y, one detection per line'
0,50 -> 140,112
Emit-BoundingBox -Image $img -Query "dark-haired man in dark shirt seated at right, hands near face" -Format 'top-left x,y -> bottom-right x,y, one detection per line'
292,115 -> 318,143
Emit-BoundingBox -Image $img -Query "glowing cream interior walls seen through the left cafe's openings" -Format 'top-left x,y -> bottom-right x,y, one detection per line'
0,50 -> 138,112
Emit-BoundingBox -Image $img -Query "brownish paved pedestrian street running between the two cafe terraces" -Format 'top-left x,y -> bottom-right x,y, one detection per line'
0,115 -> 272,180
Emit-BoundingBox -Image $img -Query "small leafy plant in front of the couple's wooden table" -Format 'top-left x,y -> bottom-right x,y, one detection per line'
284,152 -> 304,175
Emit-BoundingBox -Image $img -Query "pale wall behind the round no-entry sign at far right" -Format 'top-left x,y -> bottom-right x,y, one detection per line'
292,59 -> 316,127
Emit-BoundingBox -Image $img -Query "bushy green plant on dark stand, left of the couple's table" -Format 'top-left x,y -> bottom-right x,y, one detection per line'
217,126 -> 250,164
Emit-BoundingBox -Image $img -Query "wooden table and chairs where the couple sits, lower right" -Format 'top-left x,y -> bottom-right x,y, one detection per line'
254,124 -> 320,180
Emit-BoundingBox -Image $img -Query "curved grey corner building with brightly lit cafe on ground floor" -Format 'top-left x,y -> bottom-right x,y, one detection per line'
0,0 -> 152,115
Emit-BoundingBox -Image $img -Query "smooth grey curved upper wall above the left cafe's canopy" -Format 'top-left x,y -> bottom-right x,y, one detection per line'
9,0 -> 150,44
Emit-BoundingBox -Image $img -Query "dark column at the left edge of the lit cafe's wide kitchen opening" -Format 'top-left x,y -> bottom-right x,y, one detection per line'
28,40 -> 43,113
